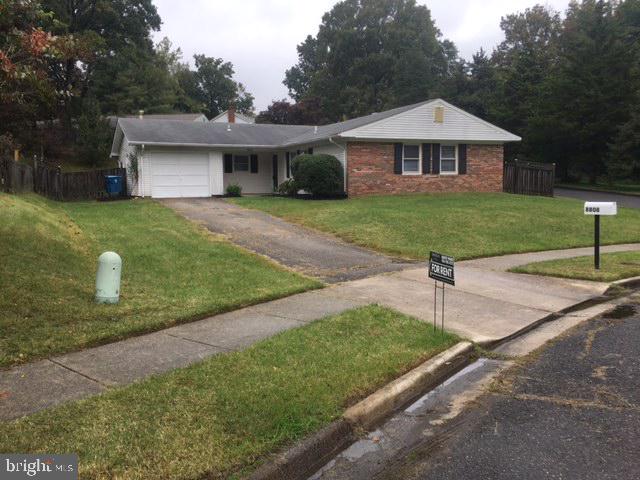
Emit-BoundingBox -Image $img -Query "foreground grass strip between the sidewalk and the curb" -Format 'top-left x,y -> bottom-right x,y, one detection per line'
0,306 -> 457,479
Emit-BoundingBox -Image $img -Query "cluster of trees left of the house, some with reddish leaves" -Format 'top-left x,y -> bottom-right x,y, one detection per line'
0,0 -> 254,165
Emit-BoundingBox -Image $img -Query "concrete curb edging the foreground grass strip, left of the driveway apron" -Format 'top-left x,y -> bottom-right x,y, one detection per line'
249,341 -> 474,480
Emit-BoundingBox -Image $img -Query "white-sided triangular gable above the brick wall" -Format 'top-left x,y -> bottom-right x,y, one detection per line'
340,100 -> 520,143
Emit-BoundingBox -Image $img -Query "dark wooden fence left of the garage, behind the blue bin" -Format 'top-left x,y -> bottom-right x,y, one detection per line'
0,158 -> 127,200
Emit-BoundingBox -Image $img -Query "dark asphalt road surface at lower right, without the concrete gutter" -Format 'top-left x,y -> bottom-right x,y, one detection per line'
376,298 -> 640,480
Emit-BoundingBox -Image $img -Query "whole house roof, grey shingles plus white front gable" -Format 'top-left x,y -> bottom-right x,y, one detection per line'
112,99 -> 521,155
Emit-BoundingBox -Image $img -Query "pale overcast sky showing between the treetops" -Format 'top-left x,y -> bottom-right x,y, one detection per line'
154,0 -> 568,111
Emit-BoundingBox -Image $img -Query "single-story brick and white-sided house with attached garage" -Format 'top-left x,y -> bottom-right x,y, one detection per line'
111,99 -> 520,198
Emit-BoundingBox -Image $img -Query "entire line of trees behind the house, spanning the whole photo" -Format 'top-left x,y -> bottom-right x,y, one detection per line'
0,0 -> 640,181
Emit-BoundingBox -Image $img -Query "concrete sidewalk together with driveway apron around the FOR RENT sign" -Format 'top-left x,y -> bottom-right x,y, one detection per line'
0,244 -> 640,420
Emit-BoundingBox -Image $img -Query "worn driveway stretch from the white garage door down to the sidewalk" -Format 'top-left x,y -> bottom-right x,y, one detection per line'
162,198 -> 412,283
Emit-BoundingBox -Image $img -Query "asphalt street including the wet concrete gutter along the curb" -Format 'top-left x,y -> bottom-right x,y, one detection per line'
311,295 -> 640,480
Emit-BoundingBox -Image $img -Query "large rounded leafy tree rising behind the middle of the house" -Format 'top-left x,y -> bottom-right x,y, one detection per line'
284,0 -> 452,120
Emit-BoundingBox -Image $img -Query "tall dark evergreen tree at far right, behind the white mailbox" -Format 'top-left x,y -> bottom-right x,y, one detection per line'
536,0 -> 635,182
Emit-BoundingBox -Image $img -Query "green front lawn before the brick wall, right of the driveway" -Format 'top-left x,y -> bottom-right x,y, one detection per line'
233,193 -> 640,260
